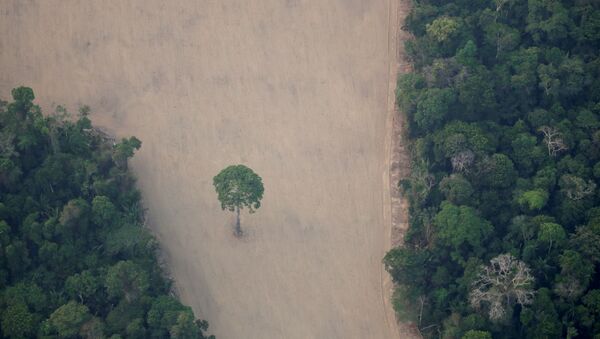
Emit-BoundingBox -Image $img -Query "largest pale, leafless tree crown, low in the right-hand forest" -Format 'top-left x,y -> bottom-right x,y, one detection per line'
469,254 -> 534,321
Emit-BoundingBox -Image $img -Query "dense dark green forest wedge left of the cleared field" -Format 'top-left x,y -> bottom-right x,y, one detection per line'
0,87 -> 212,339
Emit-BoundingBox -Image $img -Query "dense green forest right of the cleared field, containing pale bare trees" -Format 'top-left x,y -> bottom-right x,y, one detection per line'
384,0 -> 600,338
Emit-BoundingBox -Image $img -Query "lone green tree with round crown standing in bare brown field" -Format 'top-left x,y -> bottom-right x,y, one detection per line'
213,165 -> 265,236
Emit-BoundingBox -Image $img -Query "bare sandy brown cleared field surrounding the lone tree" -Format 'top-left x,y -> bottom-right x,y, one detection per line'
0,0 -> 410,339
